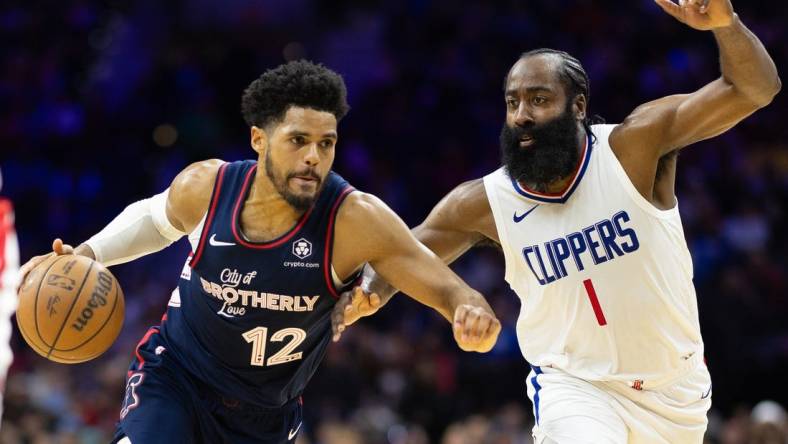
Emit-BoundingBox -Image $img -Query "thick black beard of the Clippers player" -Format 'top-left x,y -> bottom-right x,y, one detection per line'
500,108 -> 580,192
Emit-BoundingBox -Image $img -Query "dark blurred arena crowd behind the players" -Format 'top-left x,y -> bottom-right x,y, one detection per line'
0,0 -> 788,444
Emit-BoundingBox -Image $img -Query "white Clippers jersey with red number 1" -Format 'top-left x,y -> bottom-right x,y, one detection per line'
484,125 -> 703,388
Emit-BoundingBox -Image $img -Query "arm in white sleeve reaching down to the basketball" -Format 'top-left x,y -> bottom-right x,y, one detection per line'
19,159 -> 222,284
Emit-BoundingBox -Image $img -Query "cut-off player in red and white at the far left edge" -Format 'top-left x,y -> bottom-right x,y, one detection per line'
0,166 -> 19,426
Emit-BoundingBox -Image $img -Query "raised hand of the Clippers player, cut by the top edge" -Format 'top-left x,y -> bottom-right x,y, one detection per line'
654,0 -> 734,31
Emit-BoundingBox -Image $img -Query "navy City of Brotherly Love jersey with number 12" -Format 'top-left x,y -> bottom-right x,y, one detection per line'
161,161 -> 354,408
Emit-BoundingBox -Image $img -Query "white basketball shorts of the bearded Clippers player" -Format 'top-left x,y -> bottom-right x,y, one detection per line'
527,362 -> 711,444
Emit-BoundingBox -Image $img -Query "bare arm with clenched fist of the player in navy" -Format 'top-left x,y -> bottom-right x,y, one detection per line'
334,193 -> 500,352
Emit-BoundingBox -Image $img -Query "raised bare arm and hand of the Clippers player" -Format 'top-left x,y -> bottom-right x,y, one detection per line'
610,0 -> 781,171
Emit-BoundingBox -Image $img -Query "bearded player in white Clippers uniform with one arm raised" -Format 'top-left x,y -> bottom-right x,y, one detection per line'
334,0 -> 780,444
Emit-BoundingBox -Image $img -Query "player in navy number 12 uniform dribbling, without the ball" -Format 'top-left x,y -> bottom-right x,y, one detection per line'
22,61 -> 500,444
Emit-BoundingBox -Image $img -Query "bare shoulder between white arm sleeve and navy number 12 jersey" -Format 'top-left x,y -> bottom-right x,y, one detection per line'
167,159 -> 224,229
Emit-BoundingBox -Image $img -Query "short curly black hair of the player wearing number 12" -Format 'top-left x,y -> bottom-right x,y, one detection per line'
241,60 -> 350,128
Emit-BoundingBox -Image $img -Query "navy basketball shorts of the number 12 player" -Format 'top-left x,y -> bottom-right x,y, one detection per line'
112,327 -> 302,444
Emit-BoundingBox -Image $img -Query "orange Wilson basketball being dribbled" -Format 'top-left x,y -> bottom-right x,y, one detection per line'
16,254 -> 125,364
